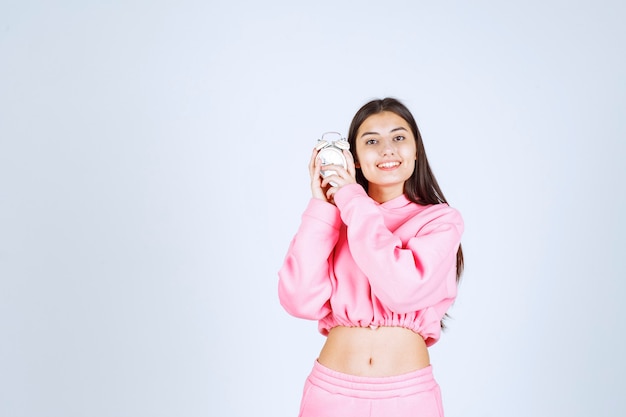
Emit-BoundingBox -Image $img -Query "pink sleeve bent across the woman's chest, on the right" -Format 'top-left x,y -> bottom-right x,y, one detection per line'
335,187 -> 464,314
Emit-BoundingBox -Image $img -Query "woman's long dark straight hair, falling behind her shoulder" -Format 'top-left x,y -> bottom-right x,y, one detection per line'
348,97 -> 464,283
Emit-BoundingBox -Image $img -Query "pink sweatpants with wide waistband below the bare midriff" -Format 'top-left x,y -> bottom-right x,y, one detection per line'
299,361 -> 443,417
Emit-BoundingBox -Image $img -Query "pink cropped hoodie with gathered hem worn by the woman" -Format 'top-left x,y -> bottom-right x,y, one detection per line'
278,184 -> 463,346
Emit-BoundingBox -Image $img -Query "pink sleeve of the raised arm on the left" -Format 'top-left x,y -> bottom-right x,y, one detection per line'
278,199 -> 342,320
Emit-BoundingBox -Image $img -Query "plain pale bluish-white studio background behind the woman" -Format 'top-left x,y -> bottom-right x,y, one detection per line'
0,0 -> 626,417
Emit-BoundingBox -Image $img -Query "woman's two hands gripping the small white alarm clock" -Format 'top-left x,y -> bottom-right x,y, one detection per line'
309,149 -> 356,204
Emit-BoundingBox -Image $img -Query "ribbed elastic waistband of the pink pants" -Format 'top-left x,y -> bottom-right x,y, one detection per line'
308,361 -> 437,398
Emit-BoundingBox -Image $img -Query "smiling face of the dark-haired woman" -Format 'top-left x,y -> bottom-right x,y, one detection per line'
355,111 -> 417,202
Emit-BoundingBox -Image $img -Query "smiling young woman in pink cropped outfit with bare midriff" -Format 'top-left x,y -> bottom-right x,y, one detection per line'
278,98 -> 463,417
